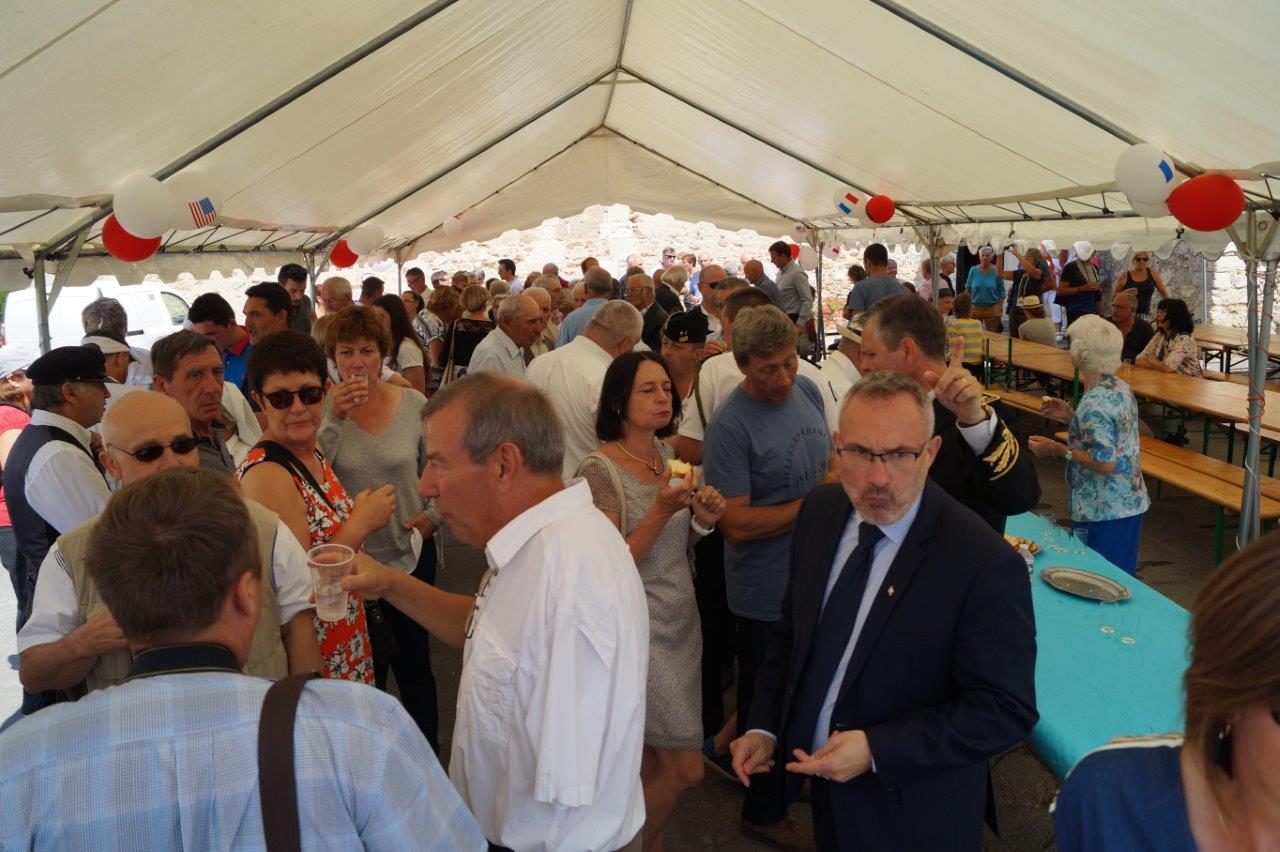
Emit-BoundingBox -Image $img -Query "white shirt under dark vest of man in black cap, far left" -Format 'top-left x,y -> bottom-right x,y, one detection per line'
23,409 -> 111,532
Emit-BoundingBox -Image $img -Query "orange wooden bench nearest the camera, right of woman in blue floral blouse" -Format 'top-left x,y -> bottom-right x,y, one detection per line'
1055,432 -> 1280,564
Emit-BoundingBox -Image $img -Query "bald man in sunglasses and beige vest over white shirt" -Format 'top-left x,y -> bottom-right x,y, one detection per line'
18,389 -> 320,693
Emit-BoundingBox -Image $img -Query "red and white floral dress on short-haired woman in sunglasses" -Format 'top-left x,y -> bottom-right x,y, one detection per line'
236,444 -> 374,686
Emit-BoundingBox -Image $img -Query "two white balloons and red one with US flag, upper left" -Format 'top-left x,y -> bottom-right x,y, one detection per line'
102,170 -> 223,262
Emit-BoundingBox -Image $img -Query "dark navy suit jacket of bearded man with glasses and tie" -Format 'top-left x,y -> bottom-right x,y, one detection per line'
746,482 -> 1038,849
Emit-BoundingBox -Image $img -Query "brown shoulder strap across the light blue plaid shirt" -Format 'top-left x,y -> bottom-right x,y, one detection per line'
257,672 -> 320,852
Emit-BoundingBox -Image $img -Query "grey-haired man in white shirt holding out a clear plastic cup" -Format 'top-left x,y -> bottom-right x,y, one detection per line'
343,373 -> 649,851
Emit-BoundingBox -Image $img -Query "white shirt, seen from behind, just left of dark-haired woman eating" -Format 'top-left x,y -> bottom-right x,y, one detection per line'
525,334 -> 614,480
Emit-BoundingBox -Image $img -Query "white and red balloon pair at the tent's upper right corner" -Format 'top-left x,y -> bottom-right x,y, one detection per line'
1116,142 -> 1244,230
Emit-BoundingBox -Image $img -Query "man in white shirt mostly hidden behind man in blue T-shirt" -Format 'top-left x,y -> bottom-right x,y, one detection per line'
676,287 -> 840,464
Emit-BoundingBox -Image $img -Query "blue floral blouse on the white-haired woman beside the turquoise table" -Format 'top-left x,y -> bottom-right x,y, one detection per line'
1066,375 -> 1151,522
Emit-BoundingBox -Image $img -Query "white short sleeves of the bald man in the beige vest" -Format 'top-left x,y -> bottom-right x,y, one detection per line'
17,521 -> 315,654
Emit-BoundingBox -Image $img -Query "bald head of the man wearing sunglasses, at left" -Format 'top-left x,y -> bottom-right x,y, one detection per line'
100,390 -> 200,485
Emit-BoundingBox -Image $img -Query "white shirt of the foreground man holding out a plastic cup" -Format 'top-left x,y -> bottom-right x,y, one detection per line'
449,478 -> 649,851
